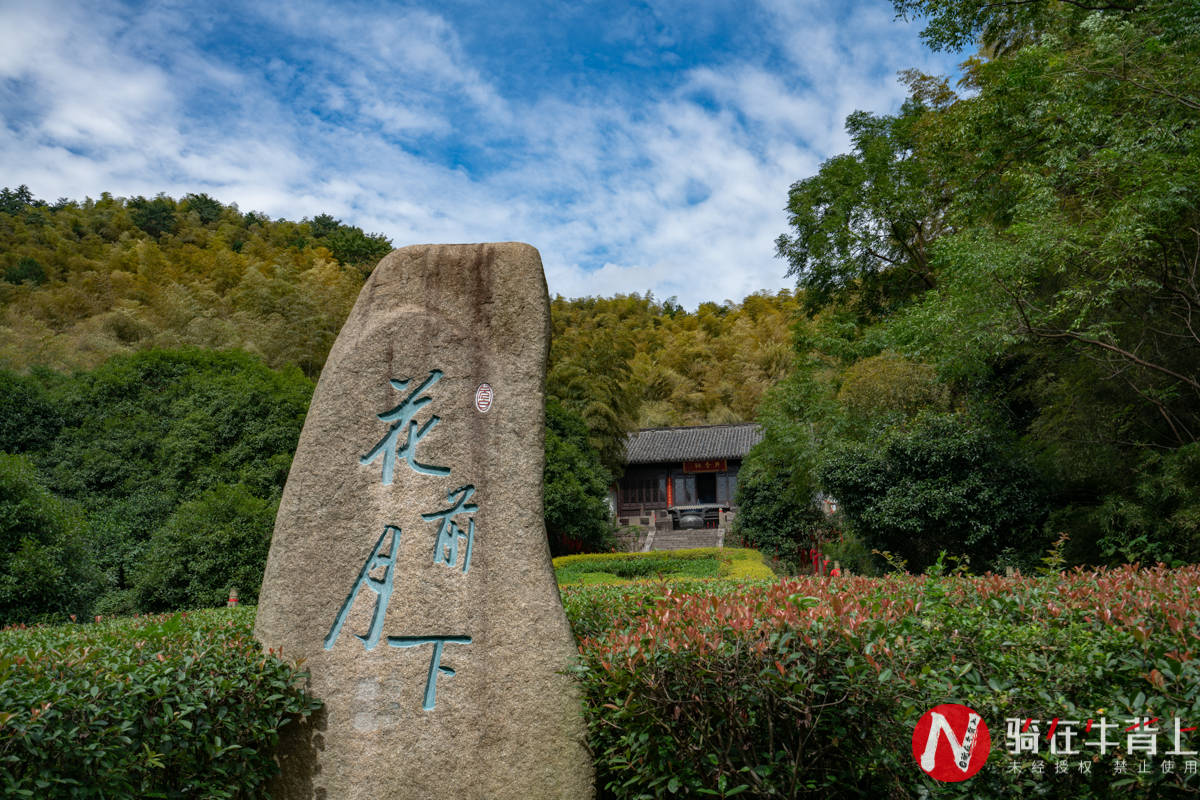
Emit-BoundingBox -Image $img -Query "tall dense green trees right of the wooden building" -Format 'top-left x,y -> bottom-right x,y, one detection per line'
743,0 -> 1200,567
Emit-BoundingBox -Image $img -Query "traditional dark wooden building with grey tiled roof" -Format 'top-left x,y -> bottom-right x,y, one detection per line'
614,423 -> 762,528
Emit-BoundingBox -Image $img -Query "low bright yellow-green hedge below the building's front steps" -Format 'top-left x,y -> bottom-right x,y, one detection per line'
554,547 -> 775,584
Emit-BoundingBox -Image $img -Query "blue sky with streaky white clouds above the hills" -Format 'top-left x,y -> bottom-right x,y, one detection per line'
0,0 -> 959,307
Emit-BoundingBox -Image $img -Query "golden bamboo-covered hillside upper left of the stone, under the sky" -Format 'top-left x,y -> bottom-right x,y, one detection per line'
0,187 -> 391,377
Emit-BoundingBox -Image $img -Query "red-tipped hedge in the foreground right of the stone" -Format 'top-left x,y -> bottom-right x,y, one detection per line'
563,566 -> 1200,799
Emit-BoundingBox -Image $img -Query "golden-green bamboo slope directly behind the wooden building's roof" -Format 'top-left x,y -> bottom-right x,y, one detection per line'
546,291 -> 798,473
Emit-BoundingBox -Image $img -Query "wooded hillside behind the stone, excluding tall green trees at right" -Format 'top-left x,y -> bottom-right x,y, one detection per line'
0,187 -> 796,620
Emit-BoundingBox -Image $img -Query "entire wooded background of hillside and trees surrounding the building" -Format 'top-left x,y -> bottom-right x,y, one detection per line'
7,0 -> 1200,619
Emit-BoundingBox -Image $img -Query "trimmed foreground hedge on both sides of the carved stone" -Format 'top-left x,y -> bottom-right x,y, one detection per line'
11,566 -> 1200,799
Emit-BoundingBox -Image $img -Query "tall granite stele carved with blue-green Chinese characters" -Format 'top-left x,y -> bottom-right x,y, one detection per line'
254,242 -> 593,800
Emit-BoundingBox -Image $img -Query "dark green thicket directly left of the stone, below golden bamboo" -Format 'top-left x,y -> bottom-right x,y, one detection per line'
20,349 -> 313,610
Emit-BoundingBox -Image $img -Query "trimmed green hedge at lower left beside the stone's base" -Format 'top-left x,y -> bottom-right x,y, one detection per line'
0,608 -> 320,800
